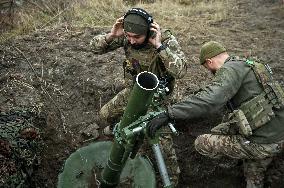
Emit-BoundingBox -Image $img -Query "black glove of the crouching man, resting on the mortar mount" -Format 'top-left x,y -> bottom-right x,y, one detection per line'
148,112 -> 170,138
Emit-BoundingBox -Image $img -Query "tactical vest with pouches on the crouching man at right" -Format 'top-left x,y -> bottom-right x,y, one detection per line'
237,60 -> 284,133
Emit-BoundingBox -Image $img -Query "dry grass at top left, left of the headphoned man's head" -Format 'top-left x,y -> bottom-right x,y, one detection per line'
0,0 -> 127,42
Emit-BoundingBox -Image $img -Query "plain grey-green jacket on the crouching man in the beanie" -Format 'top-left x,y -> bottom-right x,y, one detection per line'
168,58 -> 284,143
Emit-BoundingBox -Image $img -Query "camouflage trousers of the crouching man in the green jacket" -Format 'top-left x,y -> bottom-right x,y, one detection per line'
194,134 -> 283,188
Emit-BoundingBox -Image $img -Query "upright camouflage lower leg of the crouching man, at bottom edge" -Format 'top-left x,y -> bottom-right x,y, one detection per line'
244,158 -> 272,188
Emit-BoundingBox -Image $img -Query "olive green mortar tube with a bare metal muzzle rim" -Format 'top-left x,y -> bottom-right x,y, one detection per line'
101,72 -> 159,188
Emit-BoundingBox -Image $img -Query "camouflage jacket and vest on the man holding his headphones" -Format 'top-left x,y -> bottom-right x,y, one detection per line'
90,30 -> 186,83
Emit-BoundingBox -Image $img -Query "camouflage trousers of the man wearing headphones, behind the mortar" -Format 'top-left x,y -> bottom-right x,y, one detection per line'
99,88 -> 180,185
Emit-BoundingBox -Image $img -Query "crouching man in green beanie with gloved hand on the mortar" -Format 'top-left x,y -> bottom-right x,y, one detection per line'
148,41 -> 284,187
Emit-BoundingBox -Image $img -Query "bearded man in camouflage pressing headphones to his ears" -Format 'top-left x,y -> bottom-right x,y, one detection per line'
90,8 -> 186,187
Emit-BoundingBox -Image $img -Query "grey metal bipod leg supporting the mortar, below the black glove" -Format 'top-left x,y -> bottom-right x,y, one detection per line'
152,144 -> 173,188
